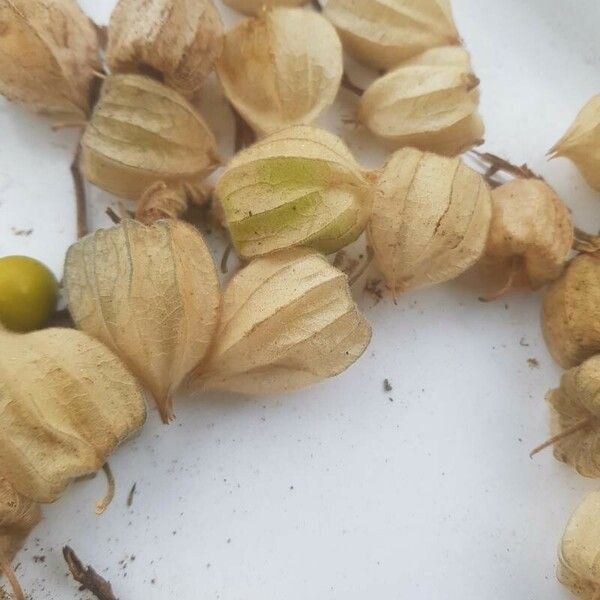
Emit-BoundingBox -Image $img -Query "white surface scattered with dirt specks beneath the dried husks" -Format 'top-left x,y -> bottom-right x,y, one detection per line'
0,0 -> 600,600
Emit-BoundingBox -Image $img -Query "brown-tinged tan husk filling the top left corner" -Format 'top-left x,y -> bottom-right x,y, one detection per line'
0,0 -> 100,123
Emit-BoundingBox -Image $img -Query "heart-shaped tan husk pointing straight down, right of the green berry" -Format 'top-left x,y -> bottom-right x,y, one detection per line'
64,220 -> 221,422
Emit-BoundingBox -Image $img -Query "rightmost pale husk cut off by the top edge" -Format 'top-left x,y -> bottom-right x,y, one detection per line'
323,0 -> 460,69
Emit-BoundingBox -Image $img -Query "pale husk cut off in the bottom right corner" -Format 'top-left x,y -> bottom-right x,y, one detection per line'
557,490 -> 600,600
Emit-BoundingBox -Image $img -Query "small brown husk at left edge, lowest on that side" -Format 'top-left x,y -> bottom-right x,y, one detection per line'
0,477 -> 42,563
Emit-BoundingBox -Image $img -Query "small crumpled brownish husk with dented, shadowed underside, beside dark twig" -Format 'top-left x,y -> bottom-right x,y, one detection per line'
483,179 -> 573,290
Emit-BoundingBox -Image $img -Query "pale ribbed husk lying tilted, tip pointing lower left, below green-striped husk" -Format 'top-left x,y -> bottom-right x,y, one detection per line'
196,248 -> 371,395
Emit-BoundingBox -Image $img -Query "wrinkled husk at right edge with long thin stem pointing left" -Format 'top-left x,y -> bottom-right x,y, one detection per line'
546,356 -> 600,477
